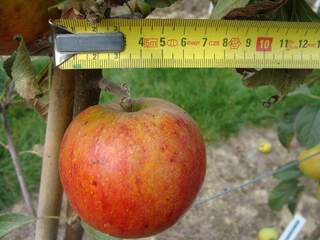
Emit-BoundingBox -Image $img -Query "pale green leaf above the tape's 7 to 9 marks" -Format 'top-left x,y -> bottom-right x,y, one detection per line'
211,0 -> 250,19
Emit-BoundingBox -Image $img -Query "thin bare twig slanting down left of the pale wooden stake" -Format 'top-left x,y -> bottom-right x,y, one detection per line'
1,107 -> 36,216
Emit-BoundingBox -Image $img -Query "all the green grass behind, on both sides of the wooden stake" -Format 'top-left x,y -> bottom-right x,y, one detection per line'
0,69 -> 320,210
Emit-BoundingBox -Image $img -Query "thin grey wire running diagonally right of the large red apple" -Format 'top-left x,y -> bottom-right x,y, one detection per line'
193,152 -> 320,207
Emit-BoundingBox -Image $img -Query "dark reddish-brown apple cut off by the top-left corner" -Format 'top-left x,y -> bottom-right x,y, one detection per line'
0,0 -> 57,55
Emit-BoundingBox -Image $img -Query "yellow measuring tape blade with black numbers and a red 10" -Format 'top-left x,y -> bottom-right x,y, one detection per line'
55,19 -> 320,69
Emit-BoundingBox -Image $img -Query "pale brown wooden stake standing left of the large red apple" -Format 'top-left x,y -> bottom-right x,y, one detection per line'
35,68 -> 74,240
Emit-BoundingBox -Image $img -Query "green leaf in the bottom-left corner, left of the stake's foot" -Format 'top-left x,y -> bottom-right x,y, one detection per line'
0,213 -> 36,238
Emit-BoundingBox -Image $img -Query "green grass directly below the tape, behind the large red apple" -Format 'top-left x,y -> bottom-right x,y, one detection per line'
102,69 -> 318,141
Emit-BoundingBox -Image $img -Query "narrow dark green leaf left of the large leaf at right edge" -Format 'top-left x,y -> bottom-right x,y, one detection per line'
278,107 -> 301,148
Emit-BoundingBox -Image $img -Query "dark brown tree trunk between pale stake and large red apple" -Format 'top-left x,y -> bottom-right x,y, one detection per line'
65,70 -> 102,240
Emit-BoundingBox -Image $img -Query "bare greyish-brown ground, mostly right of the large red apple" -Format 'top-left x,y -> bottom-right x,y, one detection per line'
4,128 -> 320,240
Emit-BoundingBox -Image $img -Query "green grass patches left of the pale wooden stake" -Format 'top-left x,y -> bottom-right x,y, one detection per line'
0,107 -> 45,210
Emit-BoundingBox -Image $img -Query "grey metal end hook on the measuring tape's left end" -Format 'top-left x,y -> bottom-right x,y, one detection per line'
49,20 -> 125,66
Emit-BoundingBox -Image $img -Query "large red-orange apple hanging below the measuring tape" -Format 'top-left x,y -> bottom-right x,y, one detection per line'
60,98 -> 206,238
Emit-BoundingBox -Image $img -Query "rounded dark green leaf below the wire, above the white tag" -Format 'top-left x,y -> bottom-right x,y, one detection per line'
268,179 -> 301,211
